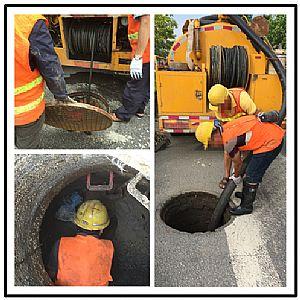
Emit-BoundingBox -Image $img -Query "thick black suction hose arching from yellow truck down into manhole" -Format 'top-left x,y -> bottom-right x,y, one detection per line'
208,15 -> 286,231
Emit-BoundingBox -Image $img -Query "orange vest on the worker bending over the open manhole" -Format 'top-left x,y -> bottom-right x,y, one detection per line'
222,115 -> 285,154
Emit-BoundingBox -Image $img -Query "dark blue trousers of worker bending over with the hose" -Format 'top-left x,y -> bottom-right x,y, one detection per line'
246,142 -> 283,183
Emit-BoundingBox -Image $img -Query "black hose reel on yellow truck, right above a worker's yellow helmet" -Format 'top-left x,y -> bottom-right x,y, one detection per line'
209,46 -> 248,88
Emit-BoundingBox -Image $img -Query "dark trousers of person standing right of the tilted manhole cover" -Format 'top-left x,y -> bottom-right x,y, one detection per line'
115,63 -> 150,121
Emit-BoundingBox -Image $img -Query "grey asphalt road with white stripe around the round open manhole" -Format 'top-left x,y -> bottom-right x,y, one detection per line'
155,136 -> 286,287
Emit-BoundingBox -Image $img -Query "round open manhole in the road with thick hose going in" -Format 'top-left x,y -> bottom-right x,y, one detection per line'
160,192 -> 231,233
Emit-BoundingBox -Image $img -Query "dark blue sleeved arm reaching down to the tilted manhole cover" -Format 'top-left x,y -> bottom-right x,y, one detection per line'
29,20 -> 67,100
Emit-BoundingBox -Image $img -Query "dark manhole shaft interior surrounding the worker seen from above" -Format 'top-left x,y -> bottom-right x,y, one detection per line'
39,170 -> 149,286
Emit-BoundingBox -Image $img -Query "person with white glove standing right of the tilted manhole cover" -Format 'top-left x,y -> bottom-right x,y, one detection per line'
112,15 -> 150,122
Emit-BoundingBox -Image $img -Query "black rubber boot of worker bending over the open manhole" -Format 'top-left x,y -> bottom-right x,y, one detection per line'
230,180 -> 258,215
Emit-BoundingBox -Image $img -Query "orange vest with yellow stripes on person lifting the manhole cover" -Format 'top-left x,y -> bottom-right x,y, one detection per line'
14,15 -> 46,126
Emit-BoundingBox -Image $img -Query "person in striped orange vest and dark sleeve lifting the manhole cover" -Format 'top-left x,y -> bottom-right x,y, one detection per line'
14,15 -> 73,148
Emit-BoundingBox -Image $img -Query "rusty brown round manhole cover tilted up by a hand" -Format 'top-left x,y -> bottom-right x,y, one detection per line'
45,103 -> 112,131
